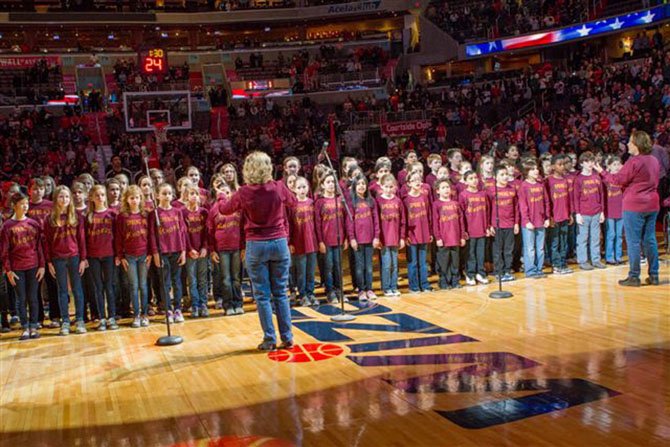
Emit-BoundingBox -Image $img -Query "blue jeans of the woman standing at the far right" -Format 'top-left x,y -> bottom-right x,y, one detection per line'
623,211 -> 658,278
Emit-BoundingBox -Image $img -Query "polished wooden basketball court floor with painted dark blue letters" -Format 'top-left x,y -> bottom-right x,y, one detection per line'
0,262 -> 670,447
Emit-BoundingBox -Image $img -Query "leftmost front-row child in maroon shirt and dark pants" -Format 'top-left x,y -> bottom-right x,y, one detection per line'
0,192 -> 44,340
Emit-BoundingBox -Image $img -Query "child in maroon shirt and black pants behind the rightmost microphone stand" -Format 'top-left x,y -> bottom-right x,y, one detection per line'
486,166 -> 520,281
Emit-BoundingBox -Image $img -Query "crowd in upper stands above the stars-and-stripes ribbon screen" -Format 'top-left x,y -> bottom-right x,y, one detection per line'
426,0 -> 589,42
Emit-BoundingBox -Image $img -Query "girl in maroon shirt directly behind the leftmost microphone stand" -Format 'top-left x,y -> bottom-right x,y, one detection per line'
149,183 -> 187,323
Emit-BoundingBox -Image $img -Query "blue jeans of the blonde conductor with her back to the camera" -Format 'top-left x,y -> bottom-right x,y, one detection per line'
246,238 -> 293,343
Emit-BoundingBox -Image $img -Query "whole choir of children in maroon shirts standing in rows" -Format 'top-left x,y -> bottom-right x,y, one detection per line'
0,149 -> 660,340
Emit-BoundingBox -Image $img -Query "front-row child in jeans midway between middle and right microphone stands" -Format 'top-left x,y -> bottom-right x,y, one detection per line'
403,171 -> 433,293
